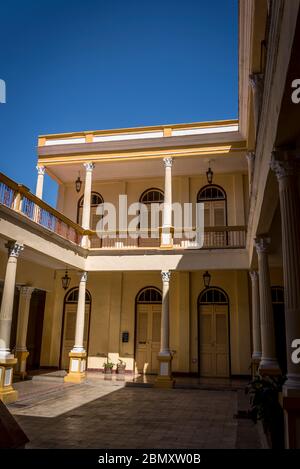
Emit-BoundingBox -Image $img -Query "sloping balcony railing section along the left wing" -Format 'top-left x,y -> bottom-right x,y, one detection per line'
0,173 -> 85,244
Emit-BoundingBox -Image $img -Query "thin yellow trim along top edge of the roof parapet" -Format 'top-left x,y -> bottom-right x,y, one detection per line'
39,119 -> 239,146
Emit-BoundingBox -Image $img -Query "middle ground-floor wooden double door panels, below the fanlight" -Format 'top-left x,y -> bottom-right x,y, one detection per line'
136,303 -> 161,374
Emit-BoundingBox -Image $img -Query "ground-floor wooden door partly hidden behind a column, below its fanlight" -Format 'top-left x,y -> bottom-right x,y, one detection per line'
60,303 -> 90,370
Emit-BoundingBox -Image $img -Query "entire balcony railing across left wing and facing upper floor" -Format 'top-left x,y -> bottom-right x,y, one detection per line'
0,173 -> 246,250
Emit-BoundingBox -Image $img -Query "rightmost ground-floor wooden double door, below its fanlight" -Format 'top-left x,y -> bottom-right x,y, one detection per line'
199,304 -> 229,377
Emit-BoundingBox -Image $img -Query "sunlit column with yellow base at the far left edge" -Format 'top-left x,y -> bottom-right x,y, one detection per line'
0,242 -> 24,404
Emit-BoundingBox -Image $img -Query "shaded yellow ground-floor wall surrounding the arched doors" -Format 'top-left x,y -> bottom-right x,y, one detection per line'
41,271 -> 250,375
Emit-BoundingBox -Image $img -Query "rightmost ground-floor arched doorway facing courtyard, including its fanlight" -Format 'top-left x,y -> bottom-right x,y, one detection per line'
198,287 -> 230,378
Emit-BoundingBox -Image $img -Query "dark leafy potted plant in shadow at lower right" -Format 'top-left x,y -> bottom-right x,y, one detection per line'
246,375 -> 286,448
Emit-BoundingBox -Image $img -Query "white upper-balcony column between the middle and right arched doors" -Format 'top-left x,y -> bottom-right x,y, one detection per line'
161,158 -> 173,247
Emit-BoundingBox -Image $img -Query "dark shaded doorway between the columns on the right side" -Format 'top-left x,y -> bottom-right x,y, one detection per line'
271,287 -> 287,374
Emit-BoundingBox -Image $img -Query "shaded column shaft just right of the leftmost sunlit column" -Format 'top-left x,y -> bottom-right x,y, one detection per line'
16,286 -> 34,352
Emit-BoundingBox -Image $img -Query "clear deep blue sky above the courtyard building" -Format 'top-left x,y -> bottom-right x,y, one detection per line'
0,0 -> 238,205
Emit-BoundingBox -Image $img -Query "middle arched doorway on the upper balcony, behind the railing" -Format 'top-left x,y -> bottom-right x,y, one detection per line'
138,188 -> 164,247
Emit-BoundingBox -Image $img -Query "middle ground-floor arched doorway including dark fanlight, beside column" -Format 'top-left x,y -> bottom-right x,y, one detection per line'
135,287 -> 162,374
